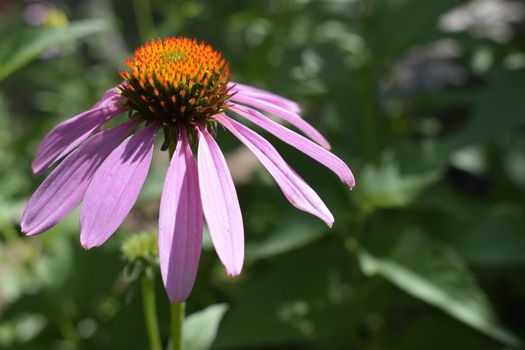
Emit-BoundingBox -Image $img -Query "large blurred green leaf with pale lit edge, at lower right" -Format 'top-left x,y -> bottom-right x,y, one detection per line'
359,232 -> 520,346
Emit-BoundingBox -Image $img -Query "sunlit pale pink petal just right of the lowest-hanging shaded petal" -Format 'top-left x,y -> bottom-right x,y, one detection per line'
198,126 -> 244,276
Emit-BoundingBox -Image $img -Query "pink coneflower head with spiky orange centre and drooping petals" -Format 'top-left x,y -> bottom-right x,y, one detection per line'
21,37 -> 354,302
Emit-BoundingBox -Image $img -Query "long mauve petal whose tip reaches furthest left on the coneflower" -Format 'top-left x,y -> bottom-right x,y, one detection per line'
21,118 -> 138,235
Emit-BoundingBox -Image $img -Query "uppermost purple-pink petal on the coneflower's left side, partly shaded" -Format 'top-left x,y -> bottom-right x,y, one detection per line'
32,91 -> 127,175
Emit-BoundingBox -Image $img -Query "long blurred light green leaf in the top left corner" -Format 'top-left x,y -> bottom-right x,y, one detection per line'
0,19 -> 110,81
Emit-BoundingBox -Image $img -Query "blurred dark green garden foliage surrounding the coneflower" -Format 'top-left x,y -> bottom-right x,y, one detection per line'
0,0 -> 525,350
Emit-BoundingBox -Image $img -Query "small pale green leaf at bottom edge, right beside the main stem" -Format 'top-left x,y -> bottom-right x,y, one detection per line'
183,304 -> 228,350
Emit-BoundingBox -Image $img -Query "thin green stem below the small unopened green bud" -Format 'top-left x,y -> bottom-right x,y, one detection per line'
141,273 -> 162,350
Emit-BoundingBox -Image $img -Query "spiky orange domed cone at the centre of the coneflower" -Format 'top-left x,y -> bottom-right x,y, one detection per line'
120,37 -> 231,127
